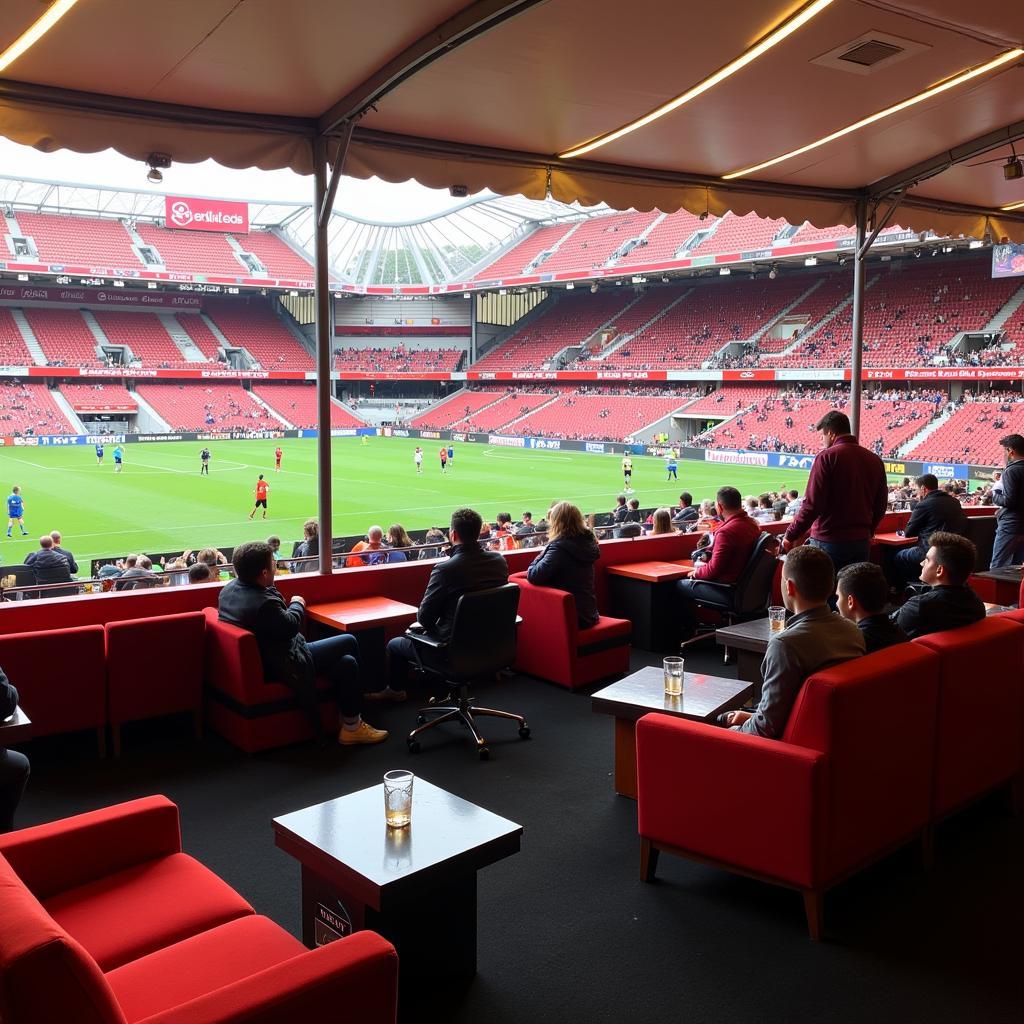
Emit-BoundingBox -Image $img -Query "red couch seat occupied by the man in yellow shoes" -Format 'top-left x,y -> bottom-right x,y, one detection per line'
206,608 -> 338,754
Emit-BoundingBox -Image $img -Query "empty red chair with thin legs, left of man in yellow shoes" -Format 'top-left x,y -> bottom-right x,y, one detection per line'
106,611 -> 206,755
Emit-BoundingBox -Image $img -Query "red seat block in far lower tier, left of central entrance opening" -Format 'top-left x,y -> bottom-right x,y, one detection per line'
515,393 -> 688,440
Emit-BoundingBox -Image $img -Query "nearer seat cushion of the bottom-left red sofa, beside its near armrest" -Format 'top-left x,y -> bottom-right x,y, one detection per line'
106,915 -> 306,1024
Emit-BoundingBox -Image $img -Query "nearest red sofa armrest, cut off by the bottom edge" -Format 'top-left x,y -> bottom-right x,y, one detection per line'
139,932 -> 398,1024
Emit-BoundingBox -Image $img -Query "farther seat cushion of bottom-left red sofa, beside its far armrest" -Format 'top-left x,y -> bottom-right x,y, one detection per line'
43,853 -> 255,972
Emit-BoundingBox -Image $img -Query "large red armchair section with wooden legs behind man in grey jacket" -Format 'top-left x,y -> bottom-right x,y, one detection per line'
637,644 -> 939,939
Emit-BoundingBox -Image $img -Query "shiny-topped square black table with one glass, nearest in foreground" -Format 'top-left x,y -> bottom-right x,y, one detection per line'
273,777 -> 522,980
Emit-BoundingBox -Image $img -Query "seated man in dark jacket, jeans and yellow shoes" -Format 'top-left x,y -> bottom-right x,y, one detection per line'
218,541 -> 387,746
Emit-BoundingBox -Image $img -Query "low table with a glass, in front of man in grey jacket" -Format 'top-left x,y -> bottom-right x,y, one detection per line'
591,667 -> 752,800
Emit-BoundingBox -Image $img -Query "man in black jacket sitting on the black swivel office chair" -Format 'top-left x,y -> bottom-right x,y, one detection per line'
378,509 -> 509,699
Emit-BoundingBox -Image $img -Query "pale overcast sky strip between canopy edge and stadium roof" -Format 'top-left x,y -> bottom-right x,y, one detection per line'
0,138 -> 487,221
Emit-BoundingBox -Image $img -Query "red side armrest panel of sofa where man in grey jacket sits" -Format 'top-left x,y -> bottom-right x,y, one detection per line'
637,715 -> 827,888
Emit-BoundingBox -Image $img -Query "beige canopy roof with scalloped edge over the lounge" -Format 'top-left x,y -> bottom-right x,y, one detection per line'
0,0 -> 1024,240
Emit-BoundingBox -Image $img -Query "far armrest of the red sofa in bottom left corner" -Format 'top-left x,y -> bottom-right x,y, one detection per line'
0,797 -> 181,899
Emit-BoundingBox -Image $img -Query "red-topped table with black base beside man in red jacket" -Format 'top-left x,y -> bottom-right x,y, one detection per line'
607,562 -> 693,650
